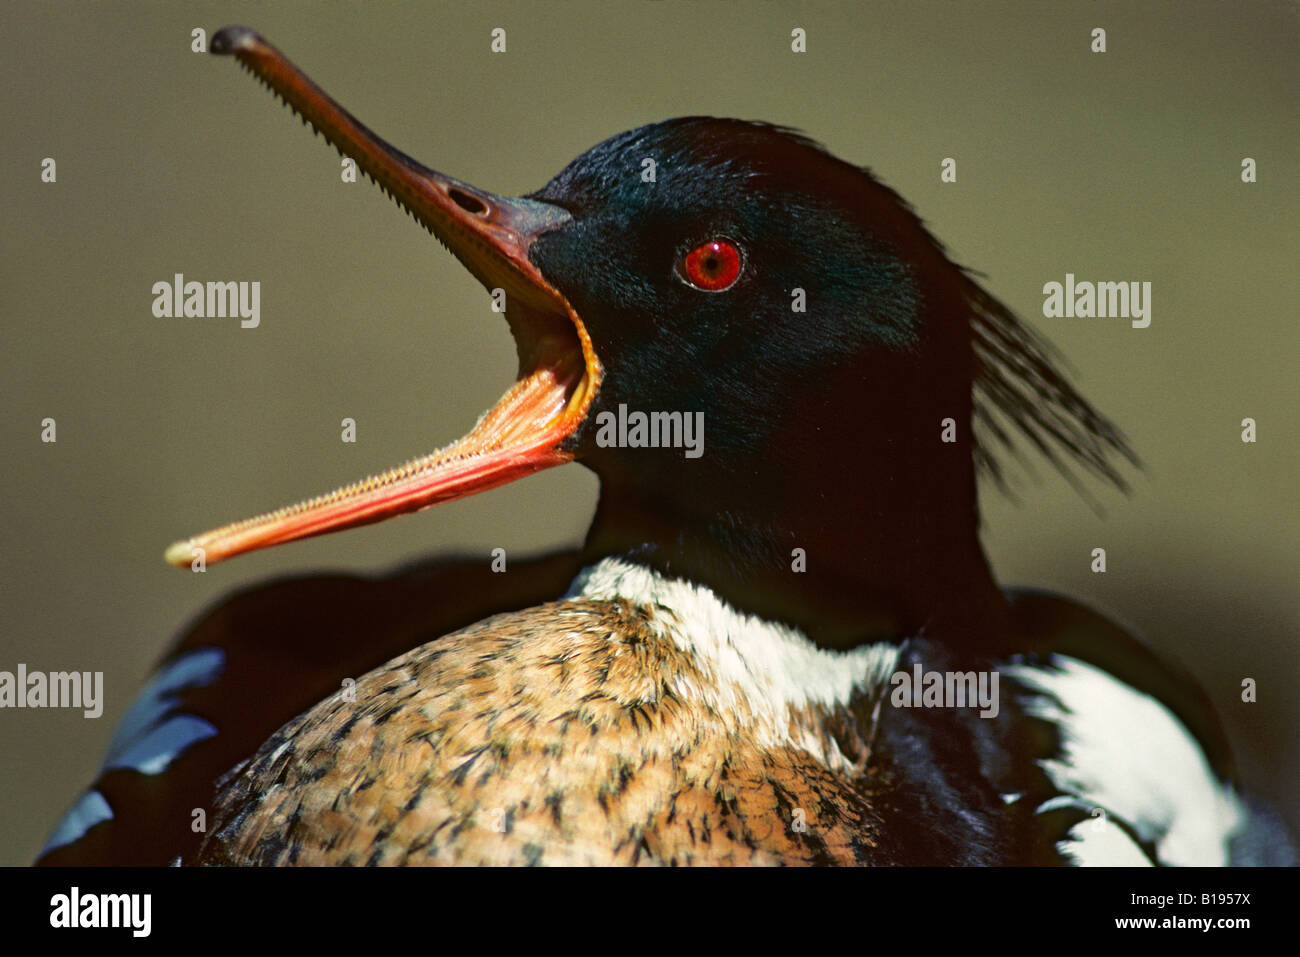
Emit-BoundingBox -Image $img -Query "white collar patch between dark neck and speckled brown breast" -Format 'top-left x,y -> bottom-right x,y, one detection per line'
564,558 -> 898,767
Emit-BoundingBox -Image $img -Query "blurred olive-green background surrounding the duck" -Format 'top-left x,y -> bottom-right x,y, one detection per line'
0,0 -> 1300,865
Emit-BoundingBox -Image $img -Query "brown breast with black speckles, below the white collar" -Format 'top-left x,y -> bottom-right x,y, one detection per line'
198,601 -> 879,865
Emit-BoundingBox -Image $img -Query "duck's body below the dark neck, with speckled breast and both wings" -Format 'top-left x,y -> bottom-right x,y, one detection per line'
43,557 -> 1287,865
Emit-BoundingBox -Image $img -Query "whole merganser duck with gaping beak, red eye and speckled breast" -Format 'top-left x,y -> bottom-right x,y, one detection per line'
40,27 -> 1292,865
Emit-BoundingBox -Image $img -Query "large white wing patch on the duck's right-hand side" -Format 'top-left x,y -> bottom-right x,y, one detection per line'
1008,655 -> 1243,866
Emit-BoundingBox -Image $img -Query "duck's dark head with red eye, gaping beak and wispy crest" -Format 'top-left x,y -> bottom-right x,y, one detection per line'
168,27 -> 1130,642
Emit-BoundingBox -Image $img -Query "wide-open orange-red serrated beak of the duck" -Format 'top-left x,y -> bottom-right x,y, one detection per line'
165,26 -> 601,567
